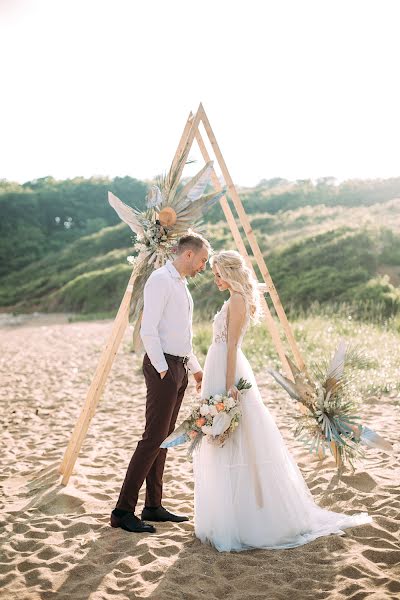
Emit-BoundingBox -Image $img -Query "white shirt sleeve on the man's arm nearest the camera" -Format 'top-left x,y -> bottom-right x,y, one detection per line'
140,276 -> 169,373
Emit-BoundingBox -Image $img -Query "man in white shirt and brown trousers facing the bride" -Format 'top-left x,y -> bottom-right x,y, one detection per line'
111,233 -> 210,533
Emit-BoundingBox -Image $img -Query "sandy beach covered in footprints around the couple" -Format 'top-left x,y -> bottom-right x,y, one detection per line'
0,317 -> 400,600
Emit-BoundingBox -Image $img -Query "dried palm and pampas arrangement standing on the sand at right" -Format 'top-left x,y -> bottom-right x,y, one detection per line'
269,341 -> 393,469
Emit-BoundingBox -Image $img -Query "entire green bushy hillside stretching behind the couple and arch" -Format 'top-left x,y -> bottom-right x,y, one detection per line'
0,178 -> 400,319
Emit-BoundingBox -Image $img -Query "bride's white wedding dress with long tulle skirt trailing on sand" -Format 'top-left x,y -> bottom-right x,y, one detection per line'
193,301 -> 372,552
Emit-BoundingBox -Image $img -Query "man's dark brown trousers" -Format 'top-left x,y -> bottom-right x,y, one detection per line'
116,354 -> 188,512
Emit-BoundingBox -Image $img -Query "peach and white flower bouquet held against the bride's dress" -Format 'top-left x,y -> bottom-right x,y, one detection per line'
160,378 -> 251,456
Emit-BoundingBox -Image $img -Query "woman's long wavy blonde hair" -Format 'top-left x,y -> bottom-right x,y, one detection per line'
210,250 -> 262,322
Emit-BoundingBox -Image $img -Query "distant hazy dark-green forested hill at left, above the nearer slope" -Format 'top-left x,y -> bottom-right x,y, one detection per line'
0,177 -> 147,277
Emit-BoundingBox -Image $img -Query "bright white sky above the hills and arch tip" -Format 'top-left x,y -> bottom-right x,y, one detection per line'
0,0 -> 400,185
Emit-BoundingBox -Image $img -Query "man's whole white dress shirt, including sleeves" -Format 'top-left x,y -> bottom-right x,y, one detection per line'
140,260 -> 201,373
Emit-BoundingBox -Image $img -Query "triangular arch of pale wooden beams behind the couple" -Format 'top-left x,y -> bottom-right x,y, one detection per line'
60,104 -> 305,485
